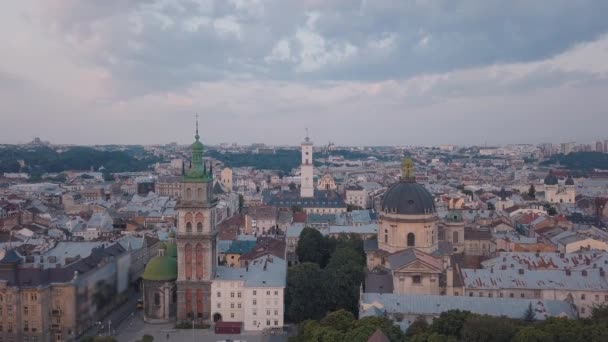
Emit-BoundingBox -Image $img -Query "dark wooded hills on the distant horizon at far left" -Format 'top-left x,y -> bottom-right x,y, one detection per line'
0,146 -> 160,178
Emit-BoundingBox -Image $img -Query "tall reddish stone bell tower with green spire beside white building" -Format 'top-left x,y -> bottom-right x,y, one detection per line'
176,119 -> 217,323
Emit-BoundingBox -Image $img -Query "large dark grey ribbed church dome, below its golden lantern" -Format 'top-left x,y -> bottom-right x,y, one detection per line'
382,181 -> 435,215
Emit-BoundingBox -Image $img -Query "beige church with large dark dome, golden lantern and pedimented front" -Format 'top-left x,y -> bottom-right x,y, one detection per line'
365,158 -> 452,294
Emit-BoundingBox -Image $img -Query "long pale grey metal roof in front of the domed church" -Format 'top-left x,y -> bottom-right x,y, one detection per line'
359,293 -> 576,320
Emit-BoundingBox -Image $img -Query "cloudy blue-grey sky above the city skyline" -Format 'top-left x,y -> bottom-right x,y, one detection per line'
0,0 -> 608,145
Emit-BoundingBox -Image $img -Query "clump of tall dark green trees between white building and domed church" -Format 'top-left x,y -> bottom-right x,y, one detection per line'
285,228 -> 365,323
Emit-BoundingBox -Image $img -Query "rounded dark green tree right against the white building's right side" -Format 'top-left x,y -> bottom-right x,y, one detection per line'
285,262 -> 327,322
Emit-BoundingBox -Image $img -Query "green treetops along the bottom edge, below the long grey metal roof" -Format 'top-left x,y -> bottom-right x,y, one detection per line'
291,307 -> 608,342
